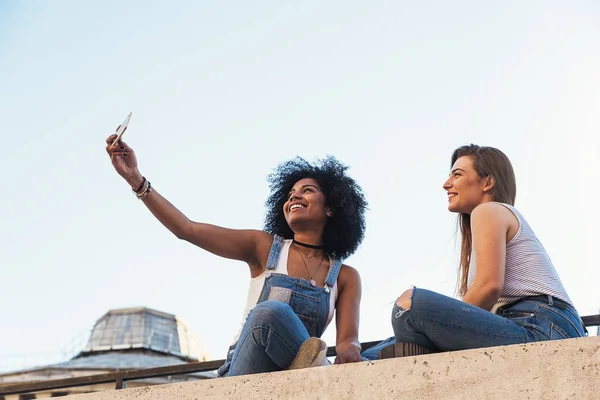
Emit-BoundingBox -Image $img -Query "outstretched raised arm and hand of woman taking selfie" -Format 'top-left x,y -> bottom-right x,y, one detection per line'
106,135 -> 273,276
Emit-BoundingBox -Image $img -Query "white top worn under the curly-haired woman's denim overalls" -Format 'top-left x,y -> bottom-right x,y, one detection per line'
233,239 -> 339,344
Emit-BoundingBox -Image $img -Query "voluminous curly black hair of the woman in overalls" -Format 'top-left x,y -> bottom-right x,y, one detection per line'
265,156 -> 367,260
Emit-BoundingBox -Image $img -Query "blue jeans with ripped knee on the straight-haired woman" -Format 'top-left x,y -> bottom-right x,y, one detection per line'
362,288 -> 586,360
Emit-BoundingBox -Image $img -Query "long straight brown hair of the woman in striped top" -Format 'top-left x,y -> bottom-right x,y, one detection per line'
450,144 -> 517,297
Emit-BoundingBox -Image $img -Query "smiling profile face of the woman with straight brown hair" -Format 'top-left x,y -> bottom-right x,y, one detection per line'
443,156 -> 494,214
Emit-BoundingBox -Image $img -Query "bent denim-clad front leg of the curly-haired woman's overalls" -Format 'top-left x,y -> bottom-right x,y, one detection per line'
227,300 -> 309,376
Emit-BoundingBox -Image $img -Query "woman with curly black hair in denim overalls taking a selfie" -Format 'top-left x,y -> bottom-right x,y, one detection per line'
106,135 -> 367,376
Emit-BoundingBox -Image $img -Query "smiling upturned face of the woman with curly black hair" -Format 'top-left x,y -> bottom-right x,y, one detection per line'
283,178 -> 331,232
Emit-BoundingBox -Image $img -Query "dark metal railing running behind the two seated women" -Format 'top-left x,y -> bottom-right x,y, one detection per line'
0,314 -> 600,396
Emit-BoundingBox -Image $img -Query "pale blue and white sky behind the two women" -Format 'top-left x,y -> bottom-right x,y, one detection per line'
0,0 -> 600,370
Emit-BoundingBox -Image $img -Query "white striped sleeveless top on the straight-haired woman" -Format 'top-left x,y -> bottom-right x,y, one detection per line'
467,203 -> 573,310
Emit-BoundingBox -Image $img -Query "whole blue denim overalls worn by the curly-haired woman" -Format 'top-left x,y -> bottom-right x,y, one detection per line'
217,236 -> 342,376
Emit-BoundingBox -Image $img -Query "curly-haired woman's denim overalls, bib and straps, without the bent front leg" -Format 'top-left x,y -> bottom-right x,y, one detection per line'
218,235 -> 342,376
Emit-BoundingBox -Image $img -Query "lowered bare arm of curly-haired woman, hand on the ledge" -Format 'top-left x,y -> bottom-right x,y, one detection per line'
335,265 -> 362,364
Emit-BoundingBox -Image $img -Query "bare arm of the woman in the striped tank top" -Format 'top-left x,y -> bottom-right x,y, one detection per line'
463,203 -> 515,310
